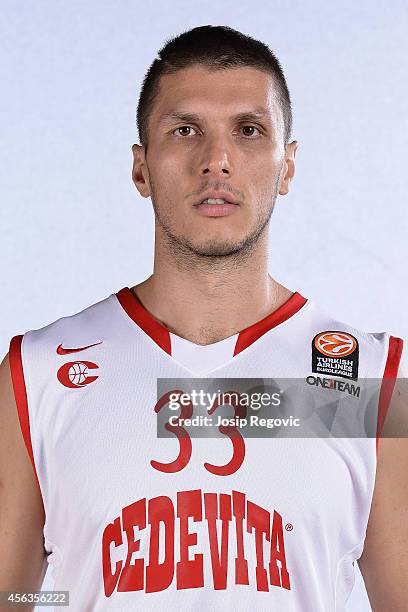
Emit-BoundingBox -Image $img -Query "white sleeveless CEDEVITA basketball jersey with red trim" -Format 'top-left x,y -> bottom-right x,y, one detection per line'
10,287 -> 403,612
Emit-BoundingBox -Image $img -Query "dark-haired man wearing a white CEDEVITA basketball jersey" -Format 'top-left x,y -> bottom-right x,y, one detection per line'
0,26 -> 408,612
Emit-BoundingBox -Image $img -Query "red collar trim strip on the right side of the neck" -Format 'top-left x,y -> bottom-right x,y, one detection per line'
234,291 -> 307,356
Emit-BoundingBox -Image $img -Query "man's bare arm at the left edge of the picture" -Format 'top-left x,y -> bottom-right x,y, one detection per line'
0,355 -> 47,612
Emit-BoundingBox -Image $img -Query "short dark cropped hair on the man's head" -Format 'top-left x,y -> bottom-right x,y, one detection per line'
136,25 -> 292,149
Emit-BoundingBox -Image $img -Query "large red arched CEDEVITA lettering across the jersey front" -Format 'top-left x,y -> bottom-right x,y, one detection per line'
102,489 -> 290,597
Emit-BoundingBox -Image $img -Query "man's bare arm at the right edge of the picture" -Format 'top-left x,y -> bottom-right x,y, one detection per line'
358,370 -> 408,612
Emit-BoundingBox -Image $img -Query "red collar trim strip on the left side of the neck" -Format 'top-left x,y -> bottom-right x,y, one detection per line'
116,287 -> 171,355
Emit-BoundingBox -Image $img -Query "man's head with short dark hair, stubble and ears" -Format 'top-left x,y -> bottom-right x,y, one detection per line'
133,26 -> 297,258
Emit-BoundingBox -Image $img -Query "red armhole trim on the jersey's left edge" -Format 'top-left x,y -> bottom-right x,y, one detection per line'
9,336 -> 41,492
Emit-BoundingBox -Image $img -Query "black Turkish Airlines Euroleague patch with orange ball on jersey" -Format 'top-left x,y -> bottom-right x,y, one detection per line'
312,330 -> 358,380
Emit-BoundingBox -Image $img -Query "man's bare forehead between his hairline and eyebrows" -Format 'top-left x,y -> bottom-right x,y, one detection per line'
151,65 -> 283,126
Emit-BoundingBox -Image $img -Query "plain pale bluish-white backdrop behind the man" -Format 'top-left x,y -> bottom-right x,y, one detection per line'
0,0 -> 408,612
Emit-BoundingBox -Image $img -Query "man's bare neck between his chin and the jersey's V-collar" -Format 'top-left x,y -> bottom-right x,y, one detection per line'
132,232 -> 292,344
